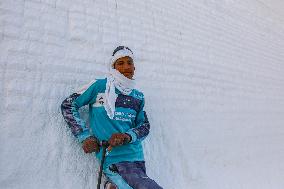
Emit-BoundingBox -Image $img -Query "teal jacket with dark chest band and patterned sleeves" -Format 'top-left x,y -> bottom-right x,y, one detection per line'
61,78 -> 150,168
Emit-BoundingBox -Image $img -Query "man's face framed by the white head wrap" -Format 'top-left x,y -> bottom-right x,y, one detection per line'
114,56 -> 135,79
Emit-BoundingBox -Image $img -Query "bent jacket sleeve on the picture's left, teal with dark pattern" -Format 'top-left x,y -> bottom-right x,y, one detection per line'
61,80 -> 97,142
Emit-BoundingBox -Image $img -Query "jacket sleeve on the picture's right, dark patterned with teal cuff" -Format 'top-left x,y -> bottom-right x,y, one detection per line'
126,98 -> 150,143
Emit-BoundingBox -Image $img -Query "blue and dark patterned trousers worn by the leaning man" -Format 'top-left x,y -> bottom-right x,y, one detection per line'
104,161 -> 163,189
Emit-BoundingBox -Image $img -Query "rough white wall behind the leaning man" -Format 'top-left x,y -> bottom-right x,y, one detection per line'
0,0 -> 284,189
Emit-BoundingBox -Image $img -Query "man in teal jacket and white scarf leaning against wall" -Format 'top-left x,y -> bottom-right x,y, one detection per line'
61,46 -> 161,189
